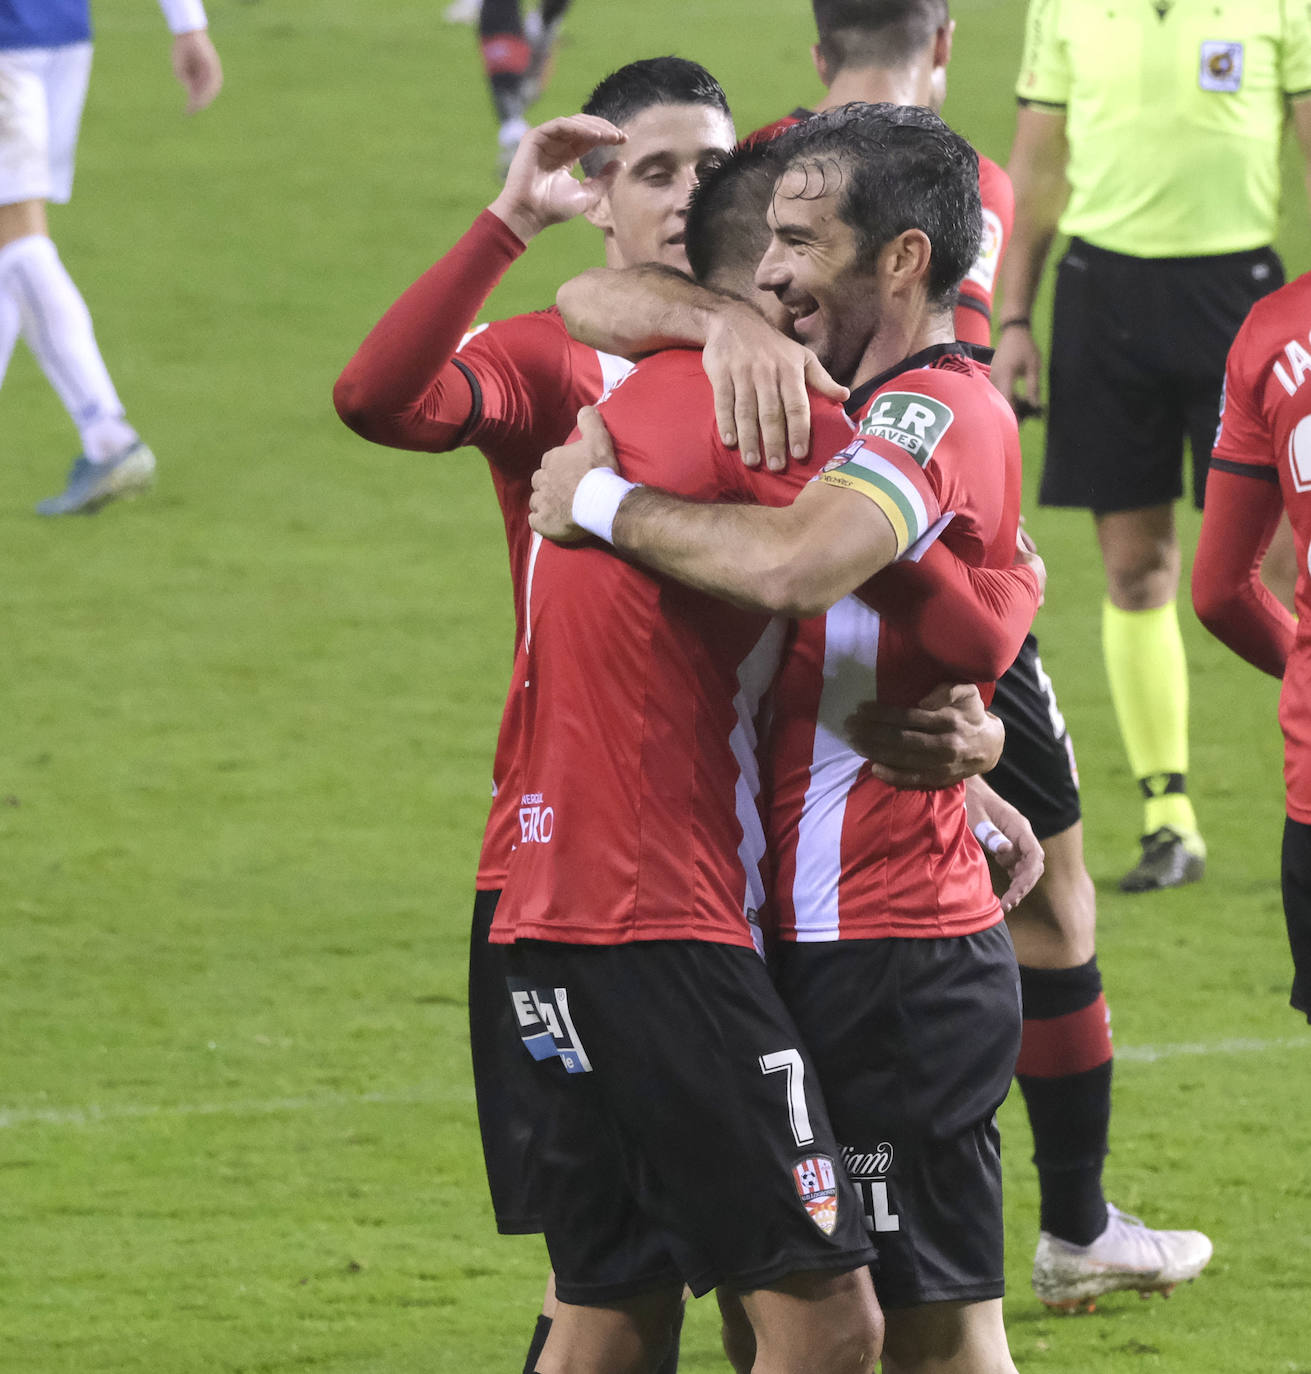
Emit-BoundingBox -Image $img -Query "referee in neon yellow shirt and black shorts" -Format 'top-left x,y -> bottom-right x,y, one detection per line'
992,0 -> 1311,892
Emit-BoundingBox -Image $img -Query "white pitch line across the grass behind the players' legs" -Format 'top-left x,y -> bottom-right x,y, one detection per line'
0,1033 -> 1311,1131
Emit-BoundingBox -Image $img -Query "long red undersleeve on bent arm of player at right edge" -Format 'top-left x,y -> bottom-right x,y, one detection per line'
1193,463 -> 1296,677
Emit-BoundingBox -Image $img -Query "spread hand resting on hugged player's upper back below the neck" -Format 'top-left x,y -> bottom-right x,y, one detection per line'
702,304 -> 849,473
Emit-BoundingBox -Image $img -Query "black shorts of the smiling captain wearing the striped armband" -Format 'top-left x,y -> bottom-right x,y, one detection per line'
776,922 -> 1020,1307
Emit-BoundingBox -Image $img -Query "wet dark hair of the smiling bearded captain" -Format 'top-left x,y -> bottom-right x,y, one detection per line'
775,102 -> 983,305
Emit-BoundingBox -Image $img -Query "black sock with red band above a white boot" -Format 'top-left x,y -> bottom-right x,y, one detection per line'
1016,955 -> 1113,1245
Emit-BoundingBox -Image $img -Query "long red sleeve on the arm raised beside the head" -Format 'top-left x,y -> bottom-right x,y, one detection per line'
333,210 -> 524,453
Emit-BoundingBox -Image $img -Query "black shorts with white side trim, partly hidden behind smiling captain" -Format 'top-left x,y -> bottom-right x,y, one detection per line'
987,635 -> 1080,840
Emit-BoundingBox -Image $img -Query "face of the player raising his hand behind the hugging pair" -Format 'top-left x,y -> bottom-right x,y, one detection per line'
588,104 -> 734,272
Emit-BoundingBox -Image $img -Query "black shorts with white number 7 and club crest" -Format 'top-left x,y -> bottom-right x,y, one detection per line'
494,940 -> 874,1304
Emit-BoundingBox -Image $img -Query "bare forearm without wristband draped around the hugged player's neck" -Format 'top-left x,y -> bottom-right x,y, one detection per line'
555,264 -> 728,359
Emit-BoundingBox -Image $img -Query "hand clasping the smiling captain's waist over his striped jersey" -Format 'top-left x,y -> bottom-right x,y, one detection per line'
845,683 -> 1006,790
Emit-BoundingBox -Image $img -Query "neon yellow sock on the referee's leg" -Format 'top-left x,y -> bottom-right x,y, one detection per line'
1102,600 -> 1197,835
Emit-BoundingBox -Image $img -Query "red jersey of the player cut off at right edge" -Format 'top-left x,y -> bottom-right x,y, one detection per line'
1194,273 -> 1311,824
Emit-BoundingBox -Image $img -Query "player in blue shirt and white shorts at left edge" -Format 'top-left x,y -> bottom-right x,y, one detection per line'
0,0 -> 223,515
